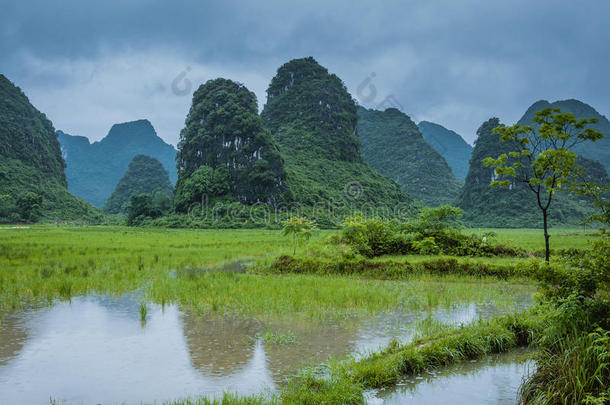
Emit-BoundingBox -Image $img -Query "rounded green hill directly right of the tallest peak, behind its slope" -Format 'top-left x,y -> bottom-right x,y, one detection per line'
358,107 -> 460,205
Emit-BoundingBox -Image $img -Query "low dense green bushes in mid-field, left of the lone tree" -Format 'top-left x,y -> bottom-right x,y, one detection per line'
335,205 -> 526,257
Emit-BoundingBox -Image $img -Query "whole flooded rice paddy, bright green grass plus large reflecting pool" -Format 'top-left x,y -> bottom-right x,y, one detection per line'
0,225 -> 597,404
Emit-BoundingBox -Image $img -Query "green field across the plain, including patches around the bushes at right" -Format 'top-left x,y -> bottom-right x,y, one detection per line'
0,226 -> 596,316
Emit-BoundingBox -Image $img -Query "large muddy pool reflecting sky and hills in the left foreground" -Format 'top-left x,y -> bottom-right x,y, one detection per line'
0,296 -> 531,404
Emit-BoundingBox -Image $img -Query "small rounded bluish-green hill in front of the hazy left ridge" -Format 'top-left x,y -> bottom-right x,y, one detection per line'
104,155 -> 173,214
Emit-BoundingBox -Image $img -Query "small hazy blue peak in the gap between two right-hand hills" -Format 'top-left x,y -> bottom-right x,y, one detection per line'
417,121 -> 473,182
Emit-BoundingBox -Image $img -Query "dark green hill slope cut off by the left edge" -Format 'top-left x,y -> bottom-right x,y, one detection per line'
0,74 -> 100,221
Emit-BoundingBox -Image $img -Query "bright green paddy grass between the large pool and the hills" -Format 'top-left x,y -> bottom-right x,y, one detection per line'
0,226 -> 535,320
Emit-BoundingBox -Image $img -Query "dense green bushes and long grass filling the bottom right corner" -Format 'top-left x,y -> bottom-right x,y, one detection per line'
521,235 -> 610,404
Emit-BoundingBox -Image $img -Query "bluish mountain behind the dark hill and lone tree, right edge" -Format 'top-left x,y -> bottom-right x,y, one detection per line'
518,99 -> 610,172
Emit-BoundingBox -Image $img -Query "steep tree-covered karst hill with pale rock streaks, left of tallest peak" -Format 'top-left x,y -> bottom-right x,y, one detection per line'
175,79 -> 285,208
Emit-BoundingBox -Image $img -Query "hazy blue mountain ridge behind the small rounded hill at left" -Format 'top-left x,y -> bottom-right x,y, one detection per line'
57,119 -> 177,207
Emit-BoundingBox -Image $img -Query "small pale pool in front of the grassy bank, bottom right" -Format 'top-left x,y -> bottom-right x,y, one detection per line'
368,350 -> 534,405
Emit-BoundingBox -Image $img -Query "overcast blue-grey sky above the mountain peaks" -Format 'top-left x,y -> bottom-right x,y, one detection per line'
0,0 -> 610,145
